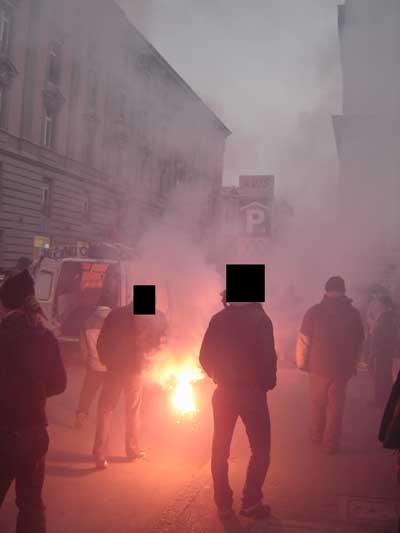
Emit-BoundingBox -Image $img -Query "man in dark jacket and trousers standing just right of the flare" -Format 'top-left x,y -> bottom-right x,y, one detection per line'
200,290 -> 277,518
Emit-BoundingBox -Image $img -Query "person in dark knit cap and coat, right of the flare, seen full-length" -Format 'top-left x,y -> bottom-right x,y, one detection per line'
296,276 -> 364,454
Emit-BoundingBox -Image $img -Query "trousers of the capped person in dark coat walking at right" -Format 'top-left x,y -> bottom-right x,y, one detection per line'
309,374 -> 349,449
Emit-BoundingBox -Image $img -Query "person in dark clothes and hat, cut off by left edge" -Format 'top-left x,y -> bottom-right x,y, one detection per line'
0,271 -> 66,533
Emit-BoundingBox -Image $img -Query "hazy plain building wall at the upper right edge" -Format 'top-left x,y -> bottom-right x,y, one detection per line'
333,0 -> 400,249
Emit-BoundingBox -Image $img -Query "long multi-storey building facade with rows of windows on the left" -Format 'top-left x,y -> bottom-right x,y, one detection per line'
0,0 -> 230,268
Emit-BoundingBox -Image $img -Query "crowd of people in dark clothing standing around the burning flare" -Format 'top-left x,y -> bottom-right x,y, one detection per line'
0,269 -> 400,533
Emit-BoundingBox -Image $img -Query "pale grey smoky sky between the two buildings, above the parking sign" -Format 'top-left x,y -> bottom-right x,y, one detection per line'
115,0 -> 341,200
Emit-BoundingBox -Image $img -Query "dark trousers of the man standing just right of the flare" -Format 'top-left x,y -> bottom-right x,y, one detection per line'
211,387 -> 271,508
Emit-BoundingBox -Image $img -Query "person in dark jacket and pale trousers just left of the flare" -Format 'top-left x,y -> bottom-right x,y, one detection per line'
93,303 -> 166,469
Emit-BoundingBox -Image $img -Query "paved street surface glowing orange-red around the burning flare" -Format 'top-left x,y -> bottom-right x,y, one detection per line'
0,360 -> 399,533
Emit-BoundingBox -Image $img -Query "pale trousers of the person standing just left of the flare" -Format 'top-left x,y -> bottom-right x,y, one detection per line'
93,372 -> 143,459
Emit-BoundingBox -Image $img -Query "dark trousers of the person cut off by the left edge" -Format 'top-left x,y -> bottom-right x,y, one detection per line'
0,428 -> 49,533
